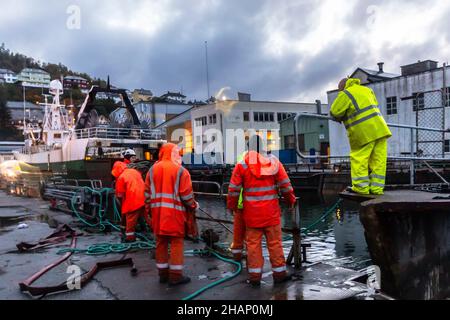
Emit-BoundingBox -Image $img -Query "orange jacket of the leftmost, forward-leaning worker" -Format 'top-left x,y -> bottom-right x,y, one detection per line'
111,161 -> 145,214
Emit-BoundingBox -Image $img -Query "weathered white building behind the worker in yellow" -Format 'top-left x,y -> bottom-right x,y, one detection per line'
328,60 -> 450,157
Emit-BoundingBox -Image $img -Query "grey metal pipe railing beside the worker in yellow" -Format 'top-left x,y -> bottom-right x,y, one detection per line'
294,113 -> 450,185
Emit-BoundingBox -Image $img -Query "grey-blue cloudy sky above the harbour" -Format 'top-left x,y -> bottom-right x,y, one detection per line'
0,0 -> 450,102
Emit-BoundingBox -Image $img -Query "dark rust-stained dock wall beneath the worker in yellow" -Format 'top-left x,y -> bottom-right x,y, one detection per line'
360,191 -> 450,300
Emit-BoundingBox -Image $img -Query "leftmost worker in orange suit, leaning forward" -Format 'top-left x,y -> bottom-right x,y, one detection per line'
111,161 -> 151,242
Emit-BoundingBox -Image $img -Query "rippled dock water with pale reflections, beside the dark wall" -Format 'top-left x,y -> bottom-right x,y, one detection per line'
197,194 -> 372,270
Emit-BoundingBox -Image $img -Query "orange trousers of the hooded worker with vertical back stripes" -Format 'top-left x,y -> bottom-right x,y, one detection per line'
156,236 -> 184,282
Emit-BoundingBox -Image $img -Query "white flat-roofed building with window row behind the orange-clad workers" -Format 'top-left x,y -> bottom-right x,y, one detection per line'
188,94 -> 317,164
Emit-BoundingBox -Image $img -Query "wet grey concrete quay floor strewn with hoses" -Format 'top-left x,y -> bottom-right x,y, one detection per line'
0,191 -> 371,300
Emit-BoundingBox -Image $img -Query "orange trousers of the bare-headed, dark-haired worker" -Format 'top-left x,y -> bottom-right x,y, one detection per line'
246,225 -> 286,282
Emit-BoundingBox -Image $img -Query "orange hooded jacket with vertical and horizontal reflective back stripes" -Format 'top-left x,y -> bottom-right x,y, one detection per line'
145,143 -> 197,237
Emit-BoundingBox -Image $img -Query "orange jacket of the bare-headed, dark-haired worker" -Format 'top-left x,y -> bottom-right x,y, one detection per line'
227,151 -> 296,228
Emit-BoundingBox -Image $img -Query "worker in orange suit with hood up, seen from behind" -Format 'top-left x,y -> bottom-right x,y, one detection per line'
145,143 -> 198,286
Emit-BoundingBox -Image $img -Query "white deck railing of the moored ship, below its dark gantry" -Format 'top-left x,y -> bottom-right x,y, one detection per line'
74,127 -> 162,140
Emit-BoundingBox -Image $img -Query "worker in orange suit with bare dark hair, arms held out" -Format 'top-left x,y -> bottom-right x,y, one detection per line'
227,136 -> 296,286
